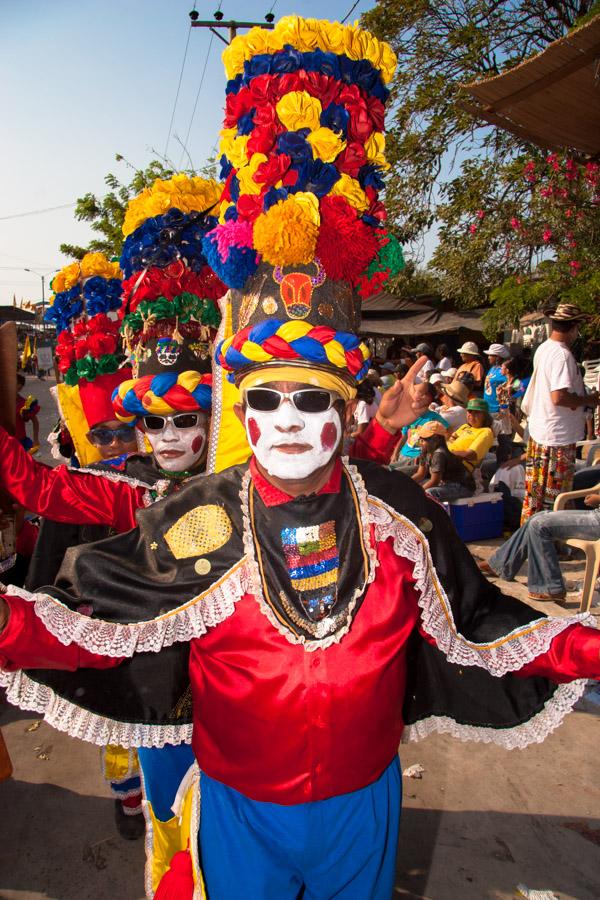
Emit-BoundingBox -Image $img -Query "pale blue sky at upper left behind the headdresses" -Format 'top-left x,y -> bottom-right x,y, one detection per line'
0,0 -> 436,305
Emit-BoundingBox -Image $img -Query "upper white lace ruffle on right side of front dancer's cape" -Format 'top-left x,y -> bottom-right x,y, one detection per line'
369,497 -> 597,676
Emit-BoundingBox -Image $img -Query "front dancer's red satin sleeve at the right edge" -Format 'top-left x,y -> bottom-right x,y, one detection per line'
515,625 -> 600,684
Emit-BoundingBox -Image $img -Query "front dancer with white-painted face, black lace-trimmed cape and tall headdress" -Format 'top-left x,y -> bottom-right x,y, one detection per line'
0,17 -> 600,900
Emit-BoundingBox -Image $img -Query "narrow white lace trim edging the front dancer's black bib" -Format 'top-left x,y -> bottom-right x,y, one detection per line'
240,459 -> 379,652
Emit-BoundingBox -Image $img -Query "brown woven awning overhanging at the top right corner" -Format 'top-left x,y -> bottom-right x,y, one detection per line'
460,15 -> 600,157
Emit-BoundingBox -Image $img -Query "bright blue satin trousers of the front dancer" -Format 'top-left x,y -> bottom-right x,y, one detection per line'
200,757 -> 402,900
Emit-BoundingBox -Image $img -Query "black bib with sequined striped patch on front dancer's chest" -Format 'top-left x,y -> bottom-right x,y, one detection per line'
248,472 -> 369,642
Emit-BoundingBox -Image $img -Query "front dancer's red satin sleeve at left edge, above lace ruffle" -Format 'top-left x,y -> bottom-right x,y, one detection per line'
0,597 -> 122,672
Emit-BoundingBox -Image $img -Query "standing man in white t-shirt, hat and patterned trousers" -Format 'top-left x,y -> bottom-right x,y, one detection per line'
521,303 -> 598,524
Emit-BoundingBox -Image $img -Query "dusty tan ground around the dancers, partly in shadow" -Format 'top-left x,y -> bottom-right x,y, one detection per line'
0,381 -> 600,900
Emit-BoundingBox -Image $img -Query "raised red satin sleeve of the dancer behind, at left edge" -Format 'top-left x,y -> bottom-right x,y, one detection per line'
0,428 -> 145,532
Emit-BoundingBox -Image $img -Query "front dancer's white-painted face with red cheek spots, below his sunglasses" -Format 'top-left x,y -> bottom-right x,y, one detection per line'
241,399 -> 342,481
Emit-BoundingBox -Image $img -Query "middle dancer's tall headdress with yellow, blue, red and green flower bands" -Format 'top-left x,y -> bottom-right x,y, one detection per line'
113,175 -> 226,421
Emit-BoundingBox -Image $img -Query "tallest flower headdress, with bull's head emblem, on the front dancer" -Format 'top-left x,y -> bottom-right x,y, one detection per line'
204,16 -> 403,472
